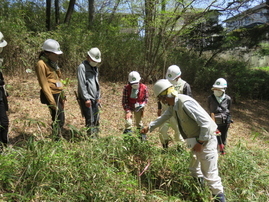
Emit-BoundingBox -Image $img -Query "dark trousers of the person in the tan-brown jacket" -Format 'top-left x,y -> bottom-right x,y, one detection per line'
47,94 -> 65,136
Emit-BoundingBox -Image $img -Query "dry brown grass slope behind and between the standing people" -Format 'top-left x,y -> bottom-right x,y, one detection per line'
5,74 -> 269,149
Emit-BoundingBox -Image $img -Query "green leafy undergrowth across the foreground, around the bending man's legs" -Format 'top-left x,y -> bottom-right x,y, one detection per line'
0,130 -> 269,202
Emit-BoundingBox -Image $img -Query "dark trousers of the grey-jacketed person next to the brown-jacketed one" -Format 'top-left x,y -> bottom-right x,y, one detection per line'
81,100 -> 99,135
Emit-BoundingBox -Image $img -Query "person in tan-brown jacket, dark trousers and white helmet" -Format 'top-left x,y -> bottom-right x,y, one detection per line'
35,39 -> 66,140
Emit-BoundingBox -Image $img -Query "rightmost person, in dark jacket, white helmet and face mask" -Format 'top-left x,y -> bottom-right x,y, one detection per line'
207,78 -> 232,155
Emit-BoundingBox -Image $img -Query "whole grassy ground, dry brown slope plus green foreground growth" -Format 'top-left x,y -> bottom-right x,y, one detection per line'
0,74 -> 269,202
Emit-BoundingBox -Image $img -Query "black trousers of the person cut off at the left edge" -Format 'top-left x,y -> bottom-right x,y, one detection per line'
0,101 -> 9,144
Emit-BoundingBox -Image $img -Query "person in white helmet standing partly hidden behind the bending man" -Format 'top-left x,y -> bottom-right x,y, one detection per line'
157,65 -> 192,149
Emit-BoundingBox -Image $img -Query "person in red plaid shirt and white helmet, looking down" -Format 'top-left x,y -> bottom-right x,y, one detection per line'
122,71 -> 149,134
